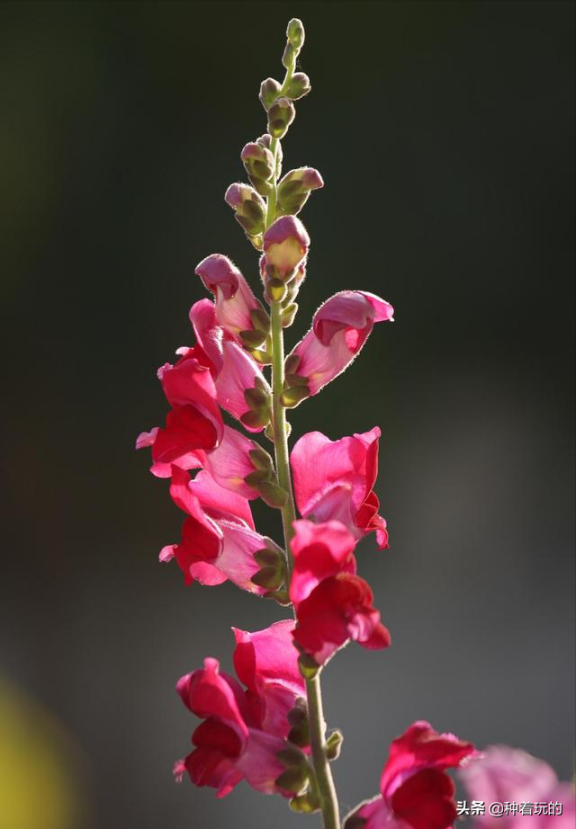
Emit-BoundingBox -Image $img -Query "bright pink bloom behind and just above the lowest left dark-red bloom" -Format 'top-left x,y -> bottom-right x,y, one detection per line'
232,619 -> 306,737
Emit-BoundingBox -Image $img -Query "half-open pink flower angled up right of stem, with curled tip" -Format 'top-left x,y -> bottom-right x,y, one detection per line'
282,291 -> 394,407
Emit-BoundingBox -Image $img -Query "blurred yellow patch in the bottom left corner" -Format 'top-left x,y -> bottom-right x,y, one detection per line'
0,679 -> 85,829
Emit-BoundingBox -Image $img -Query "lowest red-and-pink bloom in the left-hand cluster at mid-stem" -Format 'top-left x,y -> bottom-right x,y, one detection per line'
160,466 -> 282,596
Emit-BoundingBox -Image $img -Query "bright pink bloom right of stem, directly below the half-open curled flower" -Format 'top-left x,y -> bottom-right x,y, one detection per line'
290,427 -> 388,549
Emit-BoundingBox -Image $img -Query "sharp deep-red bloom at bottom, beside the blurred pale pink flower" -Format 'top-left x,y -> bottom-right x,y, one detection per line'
344,721 -> 476,829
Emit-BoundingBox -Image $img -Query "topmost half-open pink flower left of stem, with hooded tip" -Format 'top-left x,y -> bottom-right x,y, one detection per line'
196,253 -> 262,345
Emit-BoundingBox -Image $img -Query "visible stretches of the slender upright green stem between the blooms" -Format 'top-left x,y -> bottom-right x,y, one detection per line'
266,140 -> 340,829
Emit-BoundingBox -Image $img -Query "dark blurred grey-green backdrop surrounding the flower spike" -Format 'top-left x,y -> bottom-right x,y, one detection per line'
0,0 -> 574,829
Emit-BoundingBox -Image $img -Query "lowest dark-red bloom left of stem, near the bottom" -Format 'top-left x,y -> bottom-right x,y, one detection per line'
174,659 -> 297,797
